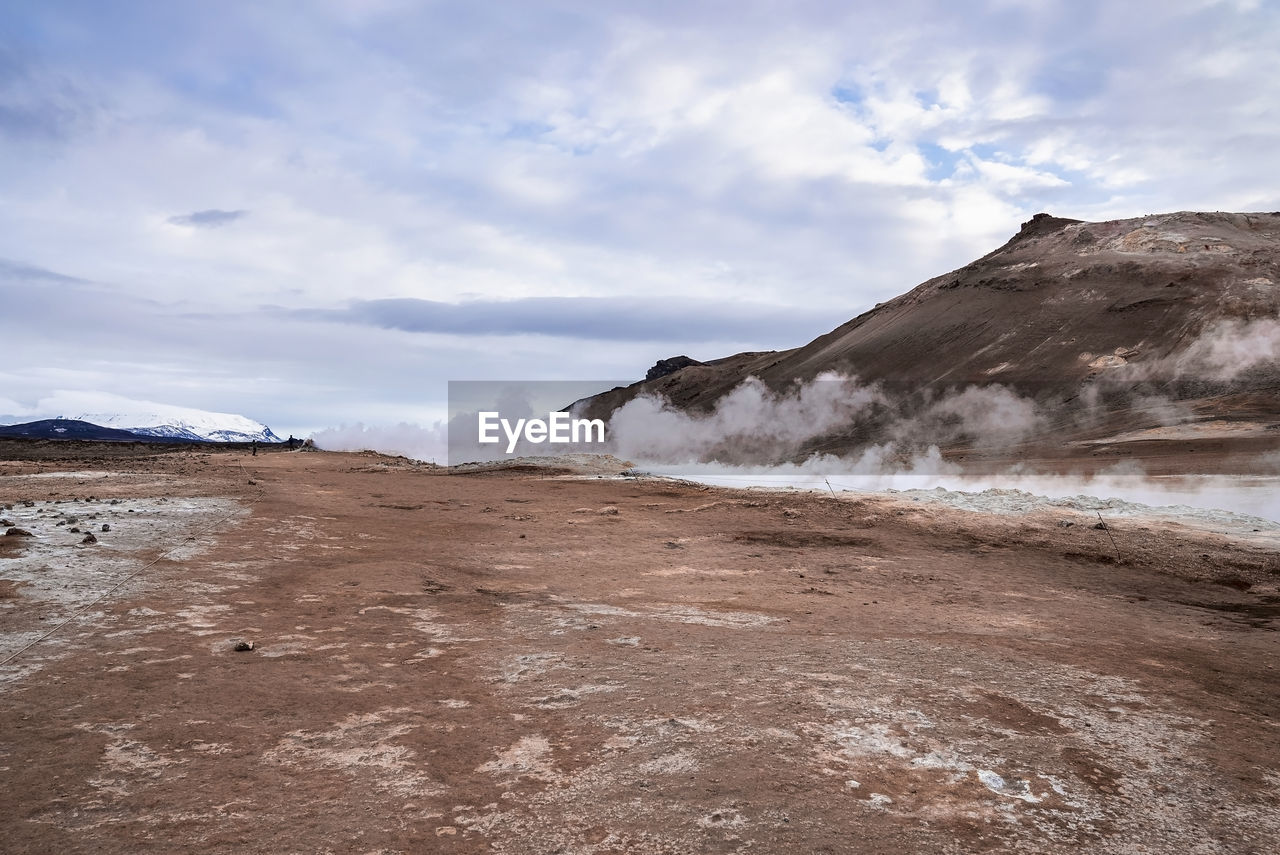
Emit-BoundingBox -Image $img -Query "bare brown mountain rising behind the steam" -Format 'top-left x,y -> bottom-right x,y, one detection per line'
577,211 -> 1280,468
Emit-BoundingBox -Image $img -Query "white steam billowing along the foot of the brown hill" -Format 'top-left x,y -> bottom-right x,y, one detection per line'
609,371 -> 1280,531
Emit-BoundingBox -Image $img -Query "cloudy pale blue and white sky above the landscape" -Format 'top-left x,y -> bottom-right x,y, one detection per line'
0,0 -> 1280,435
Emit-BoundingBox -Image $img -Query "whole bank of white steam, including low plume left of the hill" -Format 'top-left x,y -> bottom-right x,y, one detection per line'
302,317 -> 1280,520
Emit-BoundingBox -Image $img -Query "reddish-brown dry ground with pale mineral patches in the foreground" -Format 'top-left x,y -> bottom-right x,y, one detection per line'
0,451 -> 1280,855
